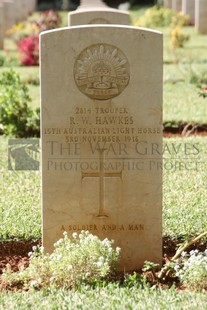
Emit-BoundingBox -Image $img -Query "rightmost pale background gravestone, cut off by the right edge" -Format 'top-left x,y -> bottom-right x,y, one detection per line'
195,0 -> 207,34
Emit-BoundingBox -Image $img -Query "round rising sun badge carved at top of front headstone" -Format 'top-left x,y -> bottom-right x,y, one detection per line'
74,44 -> 129,100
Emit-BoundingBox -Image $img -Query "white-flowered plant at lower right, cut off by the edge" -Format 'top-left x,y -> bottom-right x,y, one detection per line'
175,250 -> 207,290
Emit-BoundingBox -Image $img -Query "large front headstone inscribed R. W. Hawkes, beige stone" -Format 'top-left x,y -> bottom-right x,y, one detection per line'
41,25 -> 163,270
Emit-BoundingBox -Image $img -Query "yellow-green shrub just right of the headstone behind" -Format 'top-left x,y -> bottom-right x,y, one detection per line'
135,6 -> 189,28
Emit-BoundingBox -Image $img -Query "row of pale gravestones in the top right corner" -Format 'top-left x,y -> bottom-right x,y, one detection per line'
163,0 -> 207,34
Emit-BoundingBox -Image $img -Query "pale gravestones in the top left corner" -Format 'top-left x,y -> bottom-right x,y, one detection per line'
0,0 -> 37,49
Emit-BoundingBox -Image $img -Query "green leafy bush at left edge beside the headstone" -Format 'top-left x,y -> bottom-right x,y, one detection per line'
0,69 -> 39,137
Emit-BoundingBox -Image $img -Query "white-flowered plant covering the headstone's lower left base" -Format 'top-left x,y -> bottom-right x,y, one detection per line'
3,231 -> 120,289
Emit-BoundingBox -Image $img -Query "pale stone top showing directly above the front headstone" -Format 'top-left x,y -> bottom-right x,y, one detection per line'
68,0 -> 130,26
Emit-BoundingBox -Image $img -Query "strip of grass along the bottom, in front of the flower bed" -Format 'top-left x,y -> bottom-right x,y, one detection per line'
0,284 -> 207,310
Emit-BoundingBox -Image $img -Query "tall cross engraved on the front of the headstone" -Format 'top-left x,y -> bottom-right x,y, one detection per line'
81,149 -> 122,217
